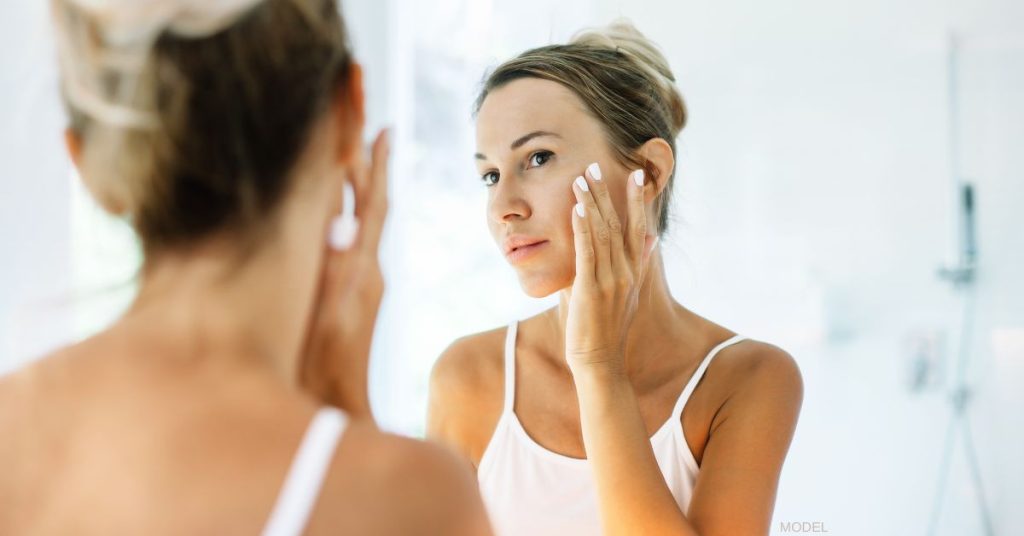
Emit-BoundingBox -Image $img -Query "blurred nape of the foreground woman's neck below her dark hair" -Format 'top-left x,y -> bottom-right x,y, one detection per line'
122,232 -> 313,384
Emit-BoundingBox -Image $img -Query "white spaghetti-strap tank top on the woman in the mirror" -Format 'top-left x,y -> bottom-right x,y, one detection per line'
476,322 -> 744,536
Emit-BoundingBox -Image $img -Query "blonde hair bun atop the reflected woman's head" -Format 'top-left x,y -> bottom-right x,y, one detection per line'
570,18 -> 686,135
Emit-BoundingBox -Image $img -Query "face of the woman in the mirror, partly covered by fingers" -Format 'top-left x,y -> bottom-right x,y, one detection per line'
476,78 -> 628,297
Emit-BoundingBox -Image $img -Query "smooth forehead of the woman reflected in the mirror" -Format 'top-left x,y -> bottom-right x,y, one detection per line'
476,78 -> 599,152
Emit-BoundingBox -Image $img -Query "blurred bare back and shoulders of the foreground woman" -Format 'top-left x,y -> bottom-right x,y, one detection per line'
0,325 -> 485,534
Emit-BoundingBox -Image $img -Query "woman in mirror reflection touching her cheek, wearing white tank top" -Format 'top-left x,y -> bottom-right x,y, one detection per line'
428,23 -> 803,536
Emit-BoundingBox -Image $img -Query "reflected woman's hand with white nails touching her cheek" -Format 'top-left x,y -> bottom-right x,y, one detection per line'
565,163 -> 652,374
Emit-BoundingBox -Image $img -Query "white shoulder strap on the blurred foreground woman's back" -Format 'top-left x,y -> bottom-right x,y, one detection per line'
263,407 -> 348,536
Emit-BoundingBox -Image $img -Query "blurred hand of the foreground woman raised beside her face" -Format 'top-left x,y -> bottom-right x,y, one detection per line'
299,131 -> 390,418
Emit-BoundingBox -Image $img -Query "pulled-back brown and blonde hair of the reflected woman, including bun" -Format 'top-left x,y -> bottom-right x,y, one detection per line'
475,20 -> 686,234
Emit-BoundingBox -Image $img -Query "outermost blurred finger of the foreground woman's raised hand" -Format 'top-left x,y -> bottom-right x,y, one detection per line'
355,130 -> 390,257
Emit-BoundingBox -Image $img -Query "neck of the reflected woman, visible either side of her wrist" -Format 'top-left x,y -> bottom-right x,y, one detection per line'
549,248 -> 696,377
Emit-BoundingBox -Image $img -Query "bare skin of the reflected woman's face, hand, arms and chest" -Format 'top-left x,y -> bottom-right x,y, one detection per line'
427,78 -> 803,536
